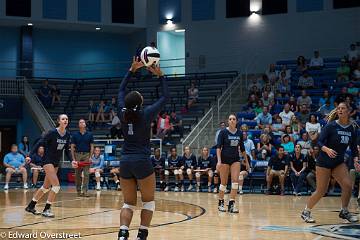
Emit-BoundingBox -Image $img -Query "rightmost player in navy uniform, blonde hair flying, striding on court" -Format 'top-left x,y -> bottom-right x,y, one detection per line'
301,103 -> 359,223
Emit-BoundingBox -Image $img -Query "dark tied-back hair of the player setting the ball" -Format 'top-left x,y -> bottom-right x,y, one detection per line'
122,91 -> 143,123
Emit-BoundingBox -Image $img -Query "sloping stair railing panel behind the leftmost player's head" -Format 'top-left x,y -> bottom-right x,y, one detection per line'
24,81 -> 55,131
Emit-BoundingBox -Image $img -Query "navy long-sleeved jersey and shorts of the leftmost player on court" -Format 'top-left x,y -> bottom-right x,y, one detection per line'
31,128 -> 72,164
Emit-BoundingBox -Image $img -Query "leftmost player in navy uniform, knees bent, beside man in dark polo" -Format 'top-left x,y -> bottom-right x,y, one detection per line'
25,114 -> 72,217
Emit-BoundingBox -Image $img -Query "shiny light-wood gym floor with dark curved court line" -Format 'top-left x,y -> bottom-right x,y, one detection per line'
0,187 -> 360,240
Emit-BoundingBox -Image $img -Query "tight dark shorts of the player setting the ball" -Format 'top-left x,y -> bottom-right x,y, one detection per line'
120,159 -> 154,179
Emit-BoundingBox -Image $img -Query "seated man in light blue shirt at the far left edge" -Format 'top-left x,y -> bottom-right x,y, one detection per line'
3,144 -> 28,190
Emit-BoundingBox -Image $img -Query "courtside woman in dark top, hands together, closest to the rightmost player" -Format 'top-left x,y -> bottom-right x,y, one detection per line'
290,144 -> 307,196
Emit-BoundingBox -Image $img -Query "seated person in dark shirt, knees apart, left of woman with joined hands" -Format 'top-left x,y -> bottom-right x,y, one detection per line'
266,146 -> 289,196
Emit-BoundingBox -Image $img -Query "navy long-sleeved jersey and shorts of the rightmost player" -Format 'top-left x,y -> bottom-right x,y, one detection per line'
317,121 -> 358,168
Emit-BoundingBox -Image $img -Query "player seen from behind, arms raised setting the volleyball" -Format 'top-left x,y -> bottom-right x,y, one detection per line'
118,57 -> 169,240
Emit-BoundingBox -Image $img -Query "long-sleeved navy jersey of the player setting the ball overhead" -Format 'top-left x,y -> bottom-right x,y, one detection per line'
118,72 -> 169,160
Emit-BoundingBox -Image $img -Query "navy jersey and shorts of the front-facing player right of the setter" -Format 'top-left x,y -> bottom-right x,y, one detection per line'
217,128 -> 245,161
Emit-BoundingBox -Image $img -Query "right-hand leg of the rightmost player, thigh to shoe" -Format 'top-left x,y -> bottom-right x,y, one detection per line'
332,163 -> 359,222
